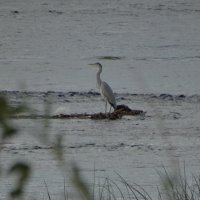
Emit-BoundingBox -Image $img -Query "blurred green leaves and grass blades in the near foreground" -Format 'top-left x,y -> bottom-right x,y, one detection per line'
0,96 -> 200,200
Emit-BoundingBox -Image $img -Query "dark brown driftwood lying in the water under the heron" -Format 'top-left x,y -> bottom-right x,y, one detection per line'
52,105 -> 145,120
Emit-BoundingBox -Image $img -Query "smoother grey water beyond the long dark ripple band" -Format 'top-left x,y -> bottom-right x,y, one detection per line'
0,0 -> 200,94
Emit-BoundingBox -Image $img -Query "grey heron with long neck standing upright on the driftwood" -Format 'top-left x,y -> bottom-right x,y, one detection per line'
90,63 -> 117,113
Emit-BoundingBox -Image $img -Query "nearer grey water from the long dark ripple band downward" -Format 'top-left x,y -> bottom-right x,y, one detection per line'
0,91 -> 200,199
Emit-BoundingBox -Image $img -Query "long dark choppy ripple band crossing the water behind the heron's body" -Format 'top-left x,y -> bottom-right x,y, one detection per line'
0,90 -> 200,103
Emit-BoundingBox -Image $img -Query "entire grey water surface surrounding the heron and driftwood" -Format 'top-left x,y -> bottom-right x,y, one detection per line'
0,0 -> 200,199
